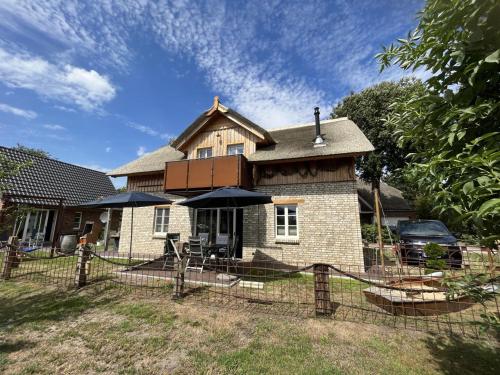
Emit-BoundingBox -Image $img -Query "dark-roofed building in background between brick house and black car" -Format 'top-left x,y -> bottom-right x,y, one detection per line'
358,179 -> 416,228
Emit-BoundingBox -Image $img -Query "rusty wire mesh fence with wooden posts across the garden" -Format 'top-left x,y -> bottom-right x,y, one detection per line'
0,242 -> 500,335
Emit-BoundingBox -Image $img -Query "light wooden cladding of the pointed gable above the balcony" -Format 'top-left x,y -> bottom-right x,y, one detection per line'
181,115 -> 261,159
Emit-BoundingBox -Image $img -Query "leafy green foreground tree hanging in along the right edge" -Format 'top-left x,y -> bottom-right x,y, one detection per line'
378,0 -> 500,246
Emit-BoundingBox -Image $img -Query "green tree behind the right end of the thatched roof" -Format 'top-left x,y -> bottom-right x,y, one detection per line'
331,78 -> 425,190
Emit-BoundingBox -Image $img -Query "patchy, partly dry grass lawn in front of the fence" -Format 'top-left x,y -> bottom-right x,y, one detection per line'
0,280 -> 500,375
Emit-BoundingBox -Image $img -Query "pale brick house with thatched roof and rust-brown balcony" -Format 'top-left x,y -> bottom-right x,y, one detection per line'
109,97 -> 373,265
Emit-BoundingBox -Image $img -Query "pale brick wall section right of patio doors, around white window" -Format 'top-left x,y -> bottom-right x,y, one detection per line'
243,181 -> 363,270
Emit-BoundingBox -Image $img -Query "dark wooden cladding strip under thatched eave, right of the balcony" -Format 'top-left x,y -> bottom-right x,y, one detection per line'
253,158 -> 356,185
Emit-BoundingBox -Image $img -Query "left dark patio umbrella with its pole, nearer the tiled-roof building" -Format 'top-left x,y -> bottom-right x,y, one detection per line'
80,191 -> 172,259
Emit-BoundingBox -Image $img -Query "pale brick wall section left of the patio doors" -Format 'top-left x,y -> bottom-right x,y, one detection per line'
120,204 -> 193,254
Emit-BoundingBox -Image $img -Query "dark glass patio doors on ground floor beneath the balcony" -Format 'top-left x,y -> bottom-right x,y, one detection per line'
194,208 -> 243,258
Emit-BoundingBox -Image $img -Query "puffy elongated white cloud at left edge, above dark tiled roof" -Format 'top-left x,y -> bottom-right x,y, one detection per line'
0,47 -> 116,111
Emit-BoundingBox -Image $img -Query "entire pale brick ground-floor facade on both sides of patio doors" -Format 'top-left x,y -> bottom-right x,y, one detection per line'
120,181 -> 363,266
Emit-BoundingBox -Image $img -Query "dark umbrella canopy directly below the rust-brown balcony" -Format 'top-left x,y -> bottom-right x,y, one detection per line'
179,187 -> 273,208
